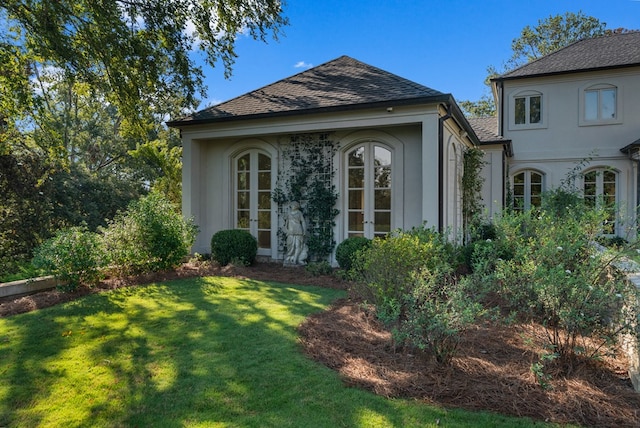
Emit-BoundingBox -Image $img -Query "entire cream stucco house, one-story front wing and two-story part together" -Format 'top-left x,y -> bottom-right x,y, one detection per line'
169,32 -> 640,260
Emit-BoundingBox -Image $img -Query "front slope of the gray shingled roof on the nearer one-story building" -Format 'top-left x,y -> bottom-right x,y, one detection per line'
168,56 -> 450,126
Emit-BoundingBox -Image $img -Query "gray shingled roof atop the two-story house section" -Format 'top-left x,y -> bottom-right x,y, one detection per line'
494,32 -> 640,80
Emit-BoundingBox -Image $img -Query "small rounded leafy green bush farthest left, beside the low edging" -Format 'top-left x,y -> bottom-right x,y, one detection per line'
33,226 -> 106,290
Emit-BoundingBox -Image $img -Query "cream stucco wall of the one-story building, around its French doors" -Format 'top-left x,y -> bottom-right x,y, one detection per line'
182,106 -> 465,258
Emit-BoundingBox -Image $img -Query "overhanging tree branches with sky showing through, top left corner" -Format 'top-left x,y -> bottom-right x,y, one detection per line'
0,0 -> 287,135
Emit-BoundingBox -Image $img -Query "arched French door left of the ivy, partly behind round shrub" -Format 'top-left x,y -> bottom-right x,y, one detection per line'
234,150 -> 271,255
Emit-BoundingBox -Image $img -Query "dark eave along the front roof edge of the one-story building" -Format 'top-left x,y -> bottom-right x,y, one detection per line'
166,94 -> 453,128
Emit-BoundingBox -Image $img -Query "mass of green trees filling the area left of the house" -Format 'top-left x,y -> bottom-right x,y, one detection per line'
0,0 -> 287,273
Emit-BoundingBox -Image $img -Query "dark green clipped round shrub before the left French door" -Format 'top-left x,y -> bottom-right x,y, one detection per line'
211,229 -> 258,266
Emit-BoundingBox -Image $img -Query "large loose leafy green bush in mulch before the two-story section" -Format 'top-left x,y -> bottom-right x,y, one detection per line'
494,199 -> 637,365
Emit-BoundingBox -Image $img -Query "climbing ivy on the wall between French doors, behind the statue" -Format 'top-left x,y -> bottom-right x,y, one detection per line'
272,134 -> 340,260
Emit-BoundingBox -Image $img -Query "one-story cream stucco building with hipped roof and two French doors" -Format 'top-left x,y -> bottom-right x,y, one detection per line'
168,56 -> 479,260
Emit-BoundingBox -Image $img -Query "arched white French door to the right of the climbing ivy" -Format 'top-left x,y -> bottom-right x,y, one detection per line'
346,142 -> 392,239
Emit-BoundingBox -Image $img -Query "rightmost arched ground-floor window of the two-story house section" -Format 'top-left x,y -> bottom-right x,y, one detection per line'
584,168 -> 617,234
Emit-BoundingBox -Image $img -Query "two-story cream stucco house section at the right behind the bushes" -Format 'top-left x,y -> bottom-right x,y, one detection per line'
482,32 -> 640,237
